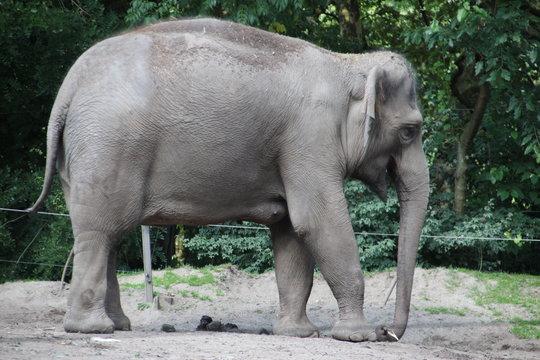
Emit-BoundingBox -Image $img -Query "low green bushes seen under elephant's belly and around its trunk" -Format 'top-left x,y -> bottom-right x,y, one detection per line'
177,180 -> 540,274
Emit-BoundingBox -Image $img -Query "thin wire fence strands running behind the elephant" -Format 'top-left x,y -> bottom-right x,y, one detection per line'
0,208 -> 540,273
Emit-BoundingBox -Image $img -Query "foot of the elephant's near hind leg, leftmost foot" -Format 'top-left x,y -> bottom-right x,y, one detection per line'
64,310 -> 115,334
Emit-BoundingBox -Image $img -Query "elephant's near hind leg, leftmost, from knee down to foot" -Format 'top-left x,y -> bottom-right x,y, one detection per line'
64,231 -> 115,333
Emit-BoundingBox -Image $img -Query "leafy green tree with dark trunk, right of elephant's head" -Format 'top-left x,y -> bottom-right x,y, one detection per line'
404,0 -> 540,214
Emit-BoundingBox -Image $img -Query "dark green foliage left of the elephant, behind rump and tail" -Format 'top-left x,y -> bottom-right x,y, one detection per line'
0,0 -> 120,281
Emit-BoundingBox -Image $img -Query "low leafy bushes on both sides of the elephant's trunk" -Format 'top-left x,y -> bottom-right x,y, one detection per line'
345,180 -> 540,274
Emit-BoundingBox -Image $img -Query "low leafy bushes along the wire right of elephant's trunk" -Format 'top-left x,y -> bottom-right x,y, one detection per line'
419,199 -> 540,274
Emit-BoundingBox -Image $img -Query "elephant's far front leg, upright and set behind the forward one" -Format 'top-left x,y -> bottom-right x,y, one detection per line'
270,218 -> 319,337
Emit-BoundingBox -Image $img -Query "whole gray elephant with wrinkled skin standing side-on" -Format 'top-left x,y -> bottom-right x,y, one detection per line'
31,19 -> 428,341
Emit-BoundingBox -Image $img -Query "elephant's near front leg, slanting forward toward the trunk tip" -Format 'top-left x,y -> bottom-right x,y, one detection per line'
287,181 -> 376,341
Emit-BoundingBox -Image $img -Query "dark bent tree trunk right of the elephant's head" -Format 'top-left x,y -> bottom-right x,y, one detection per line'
454,82 -> 489,214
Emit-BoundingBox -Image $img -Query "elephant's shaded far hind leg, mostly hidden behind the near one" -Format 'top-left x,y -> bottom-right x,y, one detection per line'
105,247 -> 131,330
